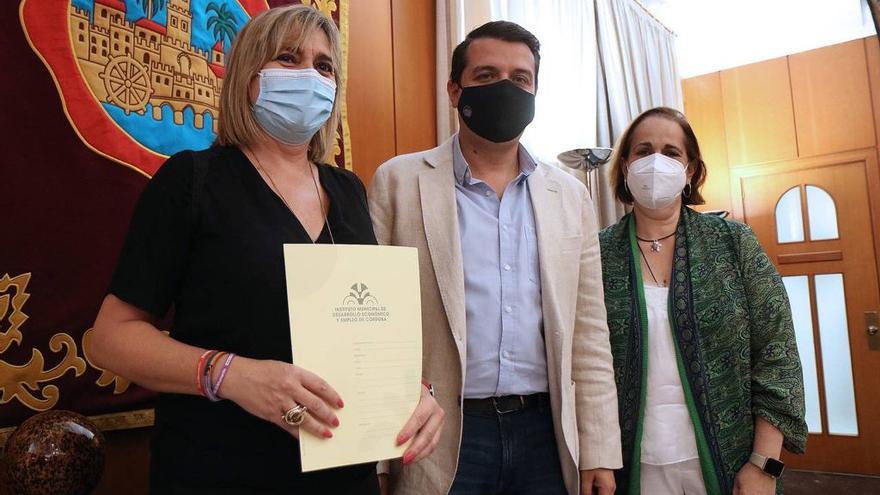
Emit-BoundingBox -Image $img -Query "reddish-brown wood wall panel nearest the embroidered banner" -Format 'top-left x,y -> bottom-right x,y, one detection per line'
348,0 -> 397,182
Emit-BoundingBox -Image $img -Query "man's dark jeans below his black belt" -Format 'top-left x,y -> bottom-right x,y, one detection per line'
449,401 -> 568,495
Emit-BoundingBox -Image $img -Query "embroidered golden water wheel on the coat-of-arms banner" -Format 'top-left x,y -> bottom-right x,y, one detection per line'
101,56 -> 153,115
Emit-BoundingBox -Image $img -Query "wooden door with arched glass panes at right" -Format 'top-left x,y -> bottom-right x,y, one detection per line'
737,151 -> 880,475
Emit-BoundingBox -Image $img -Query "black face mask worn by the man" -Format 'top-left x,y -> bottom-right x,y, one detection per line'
458,79 -> 535,143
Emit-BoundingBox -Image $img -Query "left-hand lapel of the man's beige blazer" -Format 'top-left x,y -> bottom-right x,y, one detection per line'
419,140 -> 467,363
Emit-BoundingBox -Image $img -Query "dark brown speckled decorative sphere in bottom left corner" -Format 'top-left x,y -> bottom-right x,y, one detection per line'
3,411 -> 104,495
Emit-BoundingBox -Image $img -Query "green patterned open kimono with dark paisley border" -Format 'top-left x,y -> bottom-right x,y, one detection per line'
599,207 -> 807,495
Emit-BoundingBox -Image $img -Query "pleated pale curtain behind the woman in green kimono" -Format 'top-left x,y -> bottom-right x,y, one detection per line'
591,0 -> 683,227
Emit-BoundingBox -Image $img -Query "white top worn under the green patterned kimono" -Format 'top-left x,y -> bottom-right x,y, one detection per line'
641,285 -> 699,466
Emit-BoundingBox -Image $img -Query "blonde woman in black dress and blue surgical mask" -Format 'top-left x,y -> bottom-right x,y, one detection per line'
89,5 -> 443,495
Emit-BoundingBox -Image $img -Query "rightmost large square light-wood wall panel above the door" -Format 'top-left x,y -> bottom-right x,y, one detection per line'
789,39 -> 874,157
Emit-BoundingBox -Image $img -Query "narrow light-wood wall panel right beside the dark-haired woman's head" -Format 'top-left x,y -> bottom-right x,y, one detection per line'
682,72 -> 731,215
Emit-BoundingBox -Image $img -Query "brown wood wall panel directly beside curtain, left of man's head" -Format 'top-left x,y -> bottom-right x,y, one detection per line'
391,0 -> 436,155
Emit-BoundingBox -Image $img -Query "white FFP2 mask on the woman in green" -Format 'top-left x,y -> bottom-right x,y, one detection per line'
626,153 -> 687,210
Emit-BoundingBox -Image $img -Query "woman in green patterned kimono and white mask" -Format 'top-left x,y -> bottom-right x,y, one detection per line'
600,108 -> 807,495
